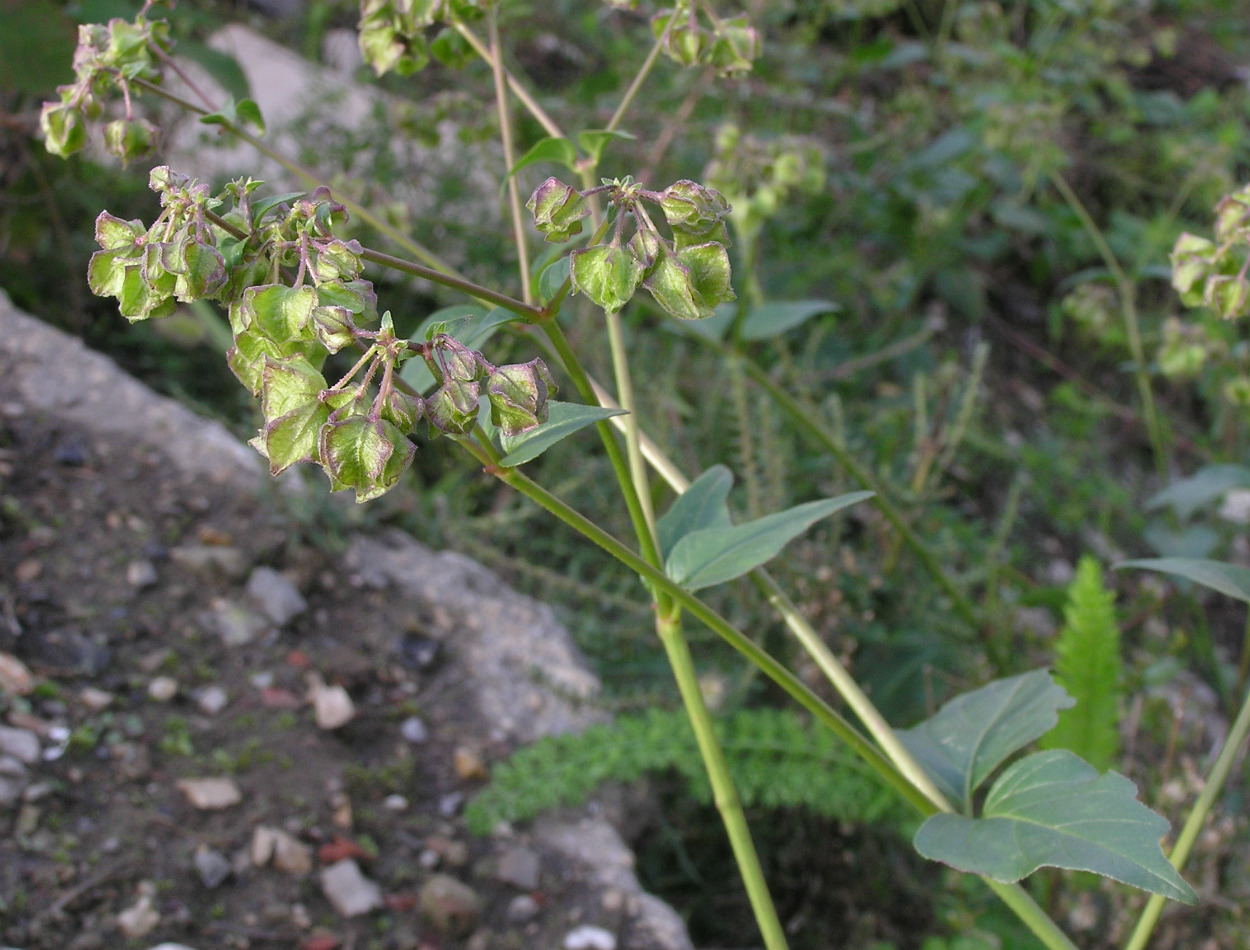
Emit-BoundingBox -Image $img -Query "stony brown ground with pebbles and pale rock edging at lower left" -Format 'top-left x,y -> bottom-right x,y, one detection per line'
0,295 -> 689,950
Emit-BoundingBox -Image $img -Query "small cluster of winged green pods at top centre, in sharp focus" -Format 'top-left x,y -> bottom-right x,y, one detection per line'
526,178 -> 734,320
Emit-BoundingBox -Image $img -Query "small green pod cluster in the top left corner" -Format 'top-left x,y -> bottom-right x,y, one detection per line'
39,14 -> 169,161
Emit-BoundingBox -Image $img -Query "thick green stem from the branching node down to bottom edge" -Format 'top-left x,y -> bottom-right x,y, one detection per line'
656,613 -> 788,950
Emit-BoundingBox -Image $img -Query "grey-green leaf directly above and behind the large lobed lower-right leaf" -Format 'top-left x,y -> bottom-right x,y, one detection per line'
899,670 -> 1073,810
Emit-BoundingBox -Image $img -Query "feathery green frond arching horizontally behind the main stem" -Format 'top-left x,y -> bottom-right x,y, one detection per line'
465,709 -> 901,834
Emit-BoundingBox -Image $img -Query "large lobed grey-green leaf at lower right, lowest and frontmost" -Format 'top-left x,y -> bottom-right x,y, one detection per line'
914,749 -> 1198,904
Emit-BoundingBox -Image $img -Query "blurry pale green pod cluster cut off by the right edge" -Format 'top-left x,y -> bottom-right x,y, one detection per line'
1171,185 -> 1250,320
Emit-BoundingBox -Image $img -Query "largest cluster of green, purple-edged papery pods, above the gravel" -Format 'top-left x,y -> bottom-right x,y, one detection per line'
89,166 -> 555,501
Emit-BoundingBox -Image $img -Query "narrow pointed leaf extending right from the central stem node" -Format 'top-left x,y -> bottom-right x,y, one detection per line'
664,491 -> 874,590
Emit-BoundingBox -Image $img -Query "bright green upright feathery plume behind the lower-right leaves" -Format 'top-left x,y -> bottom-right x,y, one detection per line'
1041,555 -> 1123,769
